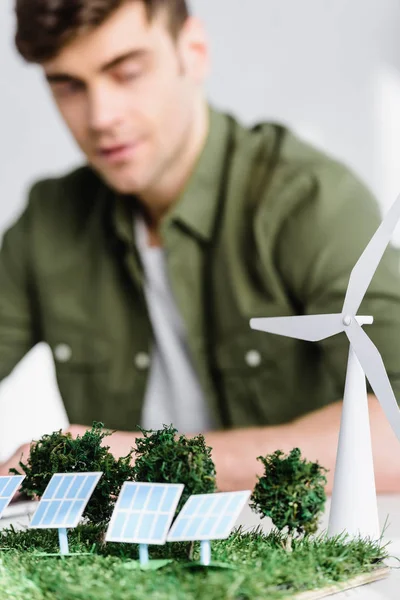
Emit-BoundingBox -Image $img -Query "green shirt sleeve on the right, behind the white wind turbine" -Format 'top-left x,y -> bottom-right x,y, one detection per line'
277,163 -> 400,401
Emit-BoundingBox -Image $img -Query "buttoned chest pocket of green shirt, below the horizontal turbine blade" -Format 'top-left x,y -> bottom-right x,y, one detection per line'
216,330 -> 330,427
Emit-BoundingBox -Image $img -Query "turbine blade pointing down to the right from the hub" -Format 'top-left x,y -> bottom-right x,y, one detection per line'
345,321 -> 400,441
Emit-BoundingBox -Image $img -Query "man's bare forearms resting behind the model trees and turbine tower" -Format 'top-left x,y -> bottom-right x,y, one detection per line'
0,396 -> 400,494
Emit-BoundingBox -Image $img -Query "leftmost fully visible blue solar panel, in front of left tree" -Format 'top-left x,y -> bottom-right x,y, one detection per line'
29,473 -> 102,529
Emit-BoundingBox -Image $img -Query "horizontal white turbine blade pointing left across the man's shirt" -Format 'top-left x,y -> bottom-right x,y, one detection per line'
250,314 -> 344,342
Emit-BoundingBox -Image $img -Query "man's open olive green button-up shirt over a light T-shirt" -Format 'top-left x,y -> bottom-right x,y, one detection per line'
0,109 -> 400,430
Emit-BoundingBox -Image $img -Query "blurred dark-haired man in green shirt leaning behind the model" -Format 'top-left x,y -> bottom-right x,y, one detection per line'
0,0 -> 400,491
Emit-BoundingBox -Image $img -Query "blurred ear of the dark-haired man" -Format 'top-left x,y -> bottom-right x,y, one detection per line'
177,16 -> 210,84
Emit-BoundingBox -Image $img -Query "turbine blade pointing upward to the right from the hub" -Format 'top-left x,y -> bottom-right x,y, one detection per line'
343,194 -> 400,315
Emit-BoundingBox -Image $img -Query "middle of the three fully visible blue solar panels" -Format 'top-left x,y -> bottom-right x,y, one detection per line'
106,481 -> 184,545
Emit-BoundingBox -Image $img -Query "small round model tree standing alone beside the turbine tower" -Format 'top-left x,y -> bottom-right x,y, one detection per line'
250,448 -> 327,549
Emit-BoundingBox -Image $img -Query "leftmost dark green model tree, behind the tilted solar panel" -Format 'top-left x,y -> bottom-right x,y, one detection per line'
10,422 -> 133,524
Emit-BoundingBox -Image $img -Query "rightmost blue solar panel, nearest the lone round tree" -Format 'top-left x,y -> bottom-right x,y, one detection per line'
167,490 -> 251,542
